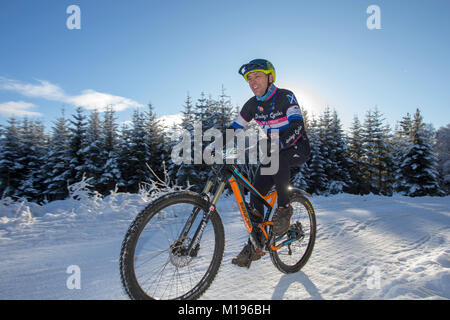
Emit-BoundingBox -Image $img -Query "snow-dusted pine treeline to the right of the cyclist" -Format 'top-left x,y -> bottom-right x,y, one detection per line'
293,108 -> 449,196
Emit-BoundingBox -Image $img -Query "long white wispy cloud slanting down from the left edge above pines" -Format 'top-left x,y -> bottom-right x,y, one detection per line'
0,77 -> 143,111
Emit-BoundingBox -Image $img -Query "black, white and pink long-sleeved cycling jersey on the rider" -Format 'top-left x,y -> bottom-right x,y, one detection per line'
232,84 -> 309,150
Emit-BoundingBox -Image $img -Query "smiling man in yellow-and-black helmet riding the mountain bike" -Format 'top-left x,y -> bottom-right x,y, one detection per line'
232,59 -> 310,267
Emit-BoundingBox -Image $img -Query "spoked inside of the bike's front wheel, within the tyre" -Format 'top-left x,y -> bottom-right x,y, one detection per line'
122,198 -> 222,299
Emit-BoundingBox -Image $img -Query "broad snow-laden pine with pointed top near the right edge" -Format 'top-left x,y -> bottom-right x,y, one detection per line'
397,109 -> 444,197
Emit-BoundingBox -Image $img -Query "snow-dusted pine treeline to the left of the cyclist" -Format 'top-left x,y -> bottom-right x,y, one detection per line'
0,89 -> 236,202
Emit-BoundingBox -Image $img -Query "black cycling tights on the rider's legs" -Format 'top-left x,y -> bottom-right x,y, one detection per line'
250,146 -> 309,218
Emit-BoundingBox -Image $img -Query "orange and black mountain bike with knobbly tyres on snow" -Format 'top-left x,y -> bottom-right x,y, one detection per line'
120,149 -> 316,300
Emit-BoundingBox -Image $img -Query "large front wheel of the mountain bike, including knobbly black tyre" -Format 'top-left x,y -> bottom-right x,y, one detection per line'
120,191 -> 225,300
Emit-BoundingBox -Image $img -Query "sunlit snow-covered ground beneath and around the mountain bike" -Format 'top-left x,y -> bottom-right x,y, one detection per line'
0,188 -> 450,299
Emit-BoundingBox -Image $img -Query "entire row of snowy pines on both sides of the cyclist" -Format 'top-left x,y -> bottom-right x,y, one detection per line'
0,88 -> 450,202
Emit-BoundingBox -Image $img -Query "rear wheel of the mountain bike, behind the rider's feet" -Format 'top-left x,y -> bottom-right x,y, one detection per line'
270,191 -> 316,273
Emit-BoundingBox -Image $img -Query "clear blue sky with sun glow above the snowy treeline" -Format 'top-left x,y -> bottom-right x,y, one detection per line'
0,0 -> 450,129
